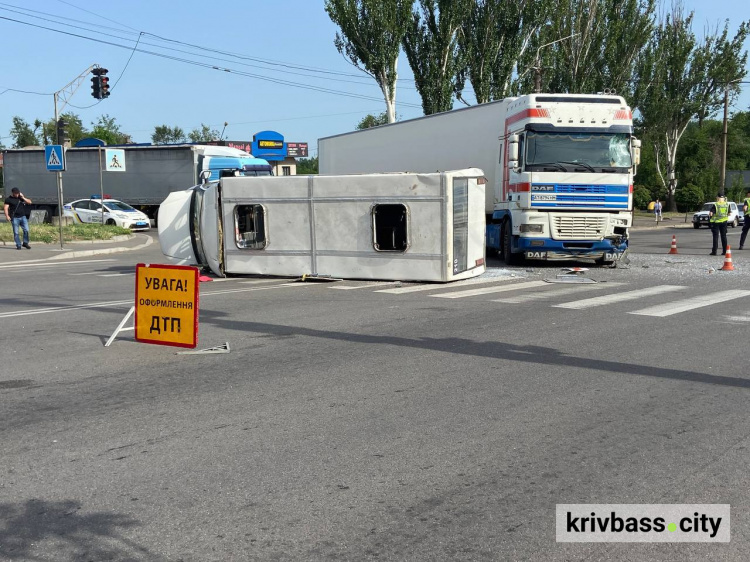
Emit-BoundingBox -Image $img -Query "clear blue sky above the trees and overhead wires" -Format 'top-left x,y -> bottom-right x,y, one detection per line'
0,0 -> 750,156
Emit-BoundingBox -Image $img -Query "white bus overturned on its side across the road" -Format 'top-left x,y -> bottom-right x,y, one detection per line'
158,165 -> 485,282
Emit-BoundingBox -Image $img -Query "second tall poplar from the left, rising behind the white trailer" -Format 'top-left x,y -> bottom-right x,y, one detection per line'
403,0 -> 475,115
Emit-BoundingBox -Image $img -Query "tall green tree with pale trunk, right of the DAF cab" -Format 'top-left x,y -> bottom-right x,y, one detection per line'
634,4 -> 750,211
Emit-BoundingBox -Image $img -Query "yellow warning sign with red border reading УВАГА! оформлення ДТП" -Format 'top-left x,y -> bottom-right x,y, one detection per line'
135,263 -> 198,347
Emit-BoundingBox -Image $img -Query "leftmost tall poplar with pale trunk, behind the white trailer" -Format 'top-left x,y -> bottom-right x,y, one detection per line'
325,0 -> 414,123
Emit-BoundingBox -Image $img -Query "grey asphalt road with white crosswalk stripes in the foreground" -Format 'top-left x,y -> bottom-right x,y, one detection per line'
0,229 -> 750,561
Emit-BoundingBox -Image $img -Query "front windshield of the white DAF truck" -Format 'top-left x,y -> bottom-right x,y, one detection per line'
526,130 -> 632,173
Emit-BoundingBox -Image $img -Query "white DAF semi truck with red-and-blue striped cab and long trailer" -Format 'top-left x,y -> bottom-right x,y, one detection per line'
318,94 -> 640,263
